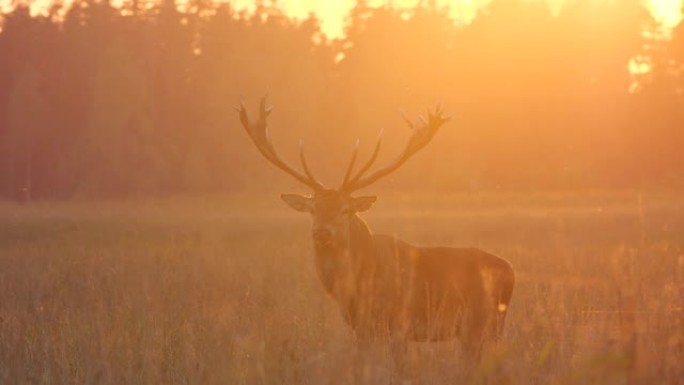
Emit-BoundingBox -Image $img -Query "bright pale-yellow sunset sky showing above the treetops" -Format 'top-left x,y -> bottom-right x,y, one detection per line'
0,0 -> 684,38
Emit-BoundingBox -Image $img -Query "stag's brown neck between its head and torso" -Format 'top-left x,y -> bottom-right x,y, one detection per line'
316,215 -> 375,296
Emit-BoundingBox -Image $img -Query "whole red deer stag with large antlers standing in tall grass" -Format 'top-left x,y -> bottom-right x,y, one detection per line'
236,98 -> 515,360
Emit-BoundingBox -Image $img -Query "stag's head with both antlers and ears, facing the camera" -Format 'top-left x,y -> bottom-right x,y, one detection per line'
236,97 -> 448,251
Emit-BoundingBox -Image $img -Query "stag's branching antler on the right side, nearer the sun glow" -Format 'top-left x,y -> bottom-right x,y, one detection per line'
340,106 -> 449,193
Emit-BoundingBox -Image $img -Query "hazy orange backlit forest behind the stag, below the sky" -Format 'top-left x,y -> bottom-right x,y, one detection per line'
0,0 -> 684,200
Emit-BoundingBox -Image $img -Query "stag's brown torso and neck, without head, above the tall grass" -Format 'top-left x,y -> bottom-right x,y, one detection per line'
300,206 -> 515,355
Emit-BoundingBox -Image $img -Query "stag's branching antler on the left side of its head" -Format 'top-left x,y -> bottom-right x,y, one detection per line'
235,96 -> 325,190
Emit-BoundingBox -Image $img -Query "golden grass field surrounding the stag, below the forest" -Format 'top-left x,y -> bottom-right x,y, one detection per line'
0,192 -> 684,384
